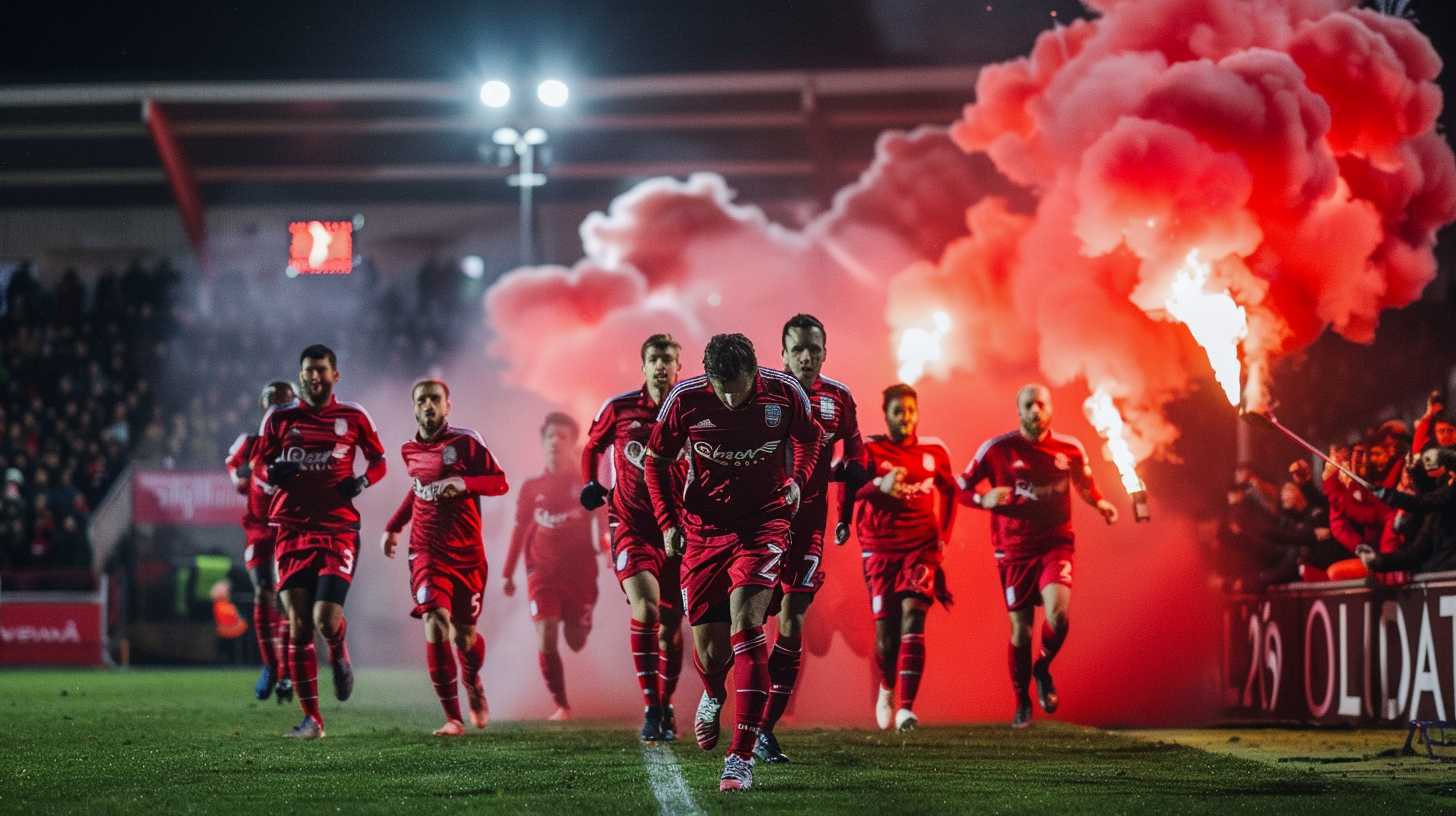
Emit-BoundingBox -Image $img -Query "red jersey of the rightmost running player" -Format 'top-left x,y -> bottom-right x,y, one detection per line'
961,431 -> 1102,555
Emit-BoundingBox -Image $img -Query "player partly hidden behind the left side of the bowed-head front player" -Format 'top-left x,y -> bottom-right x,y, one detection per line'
581,334 -> 683,740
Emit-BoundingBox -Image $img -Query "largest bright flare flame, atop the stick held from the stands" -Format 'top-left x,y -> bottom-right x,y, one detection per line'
1163,249 -> 1249,405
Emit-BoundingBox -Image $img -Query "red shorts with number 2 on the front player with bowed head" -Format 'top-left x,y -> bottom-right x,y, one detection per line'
683,519 -> 789,627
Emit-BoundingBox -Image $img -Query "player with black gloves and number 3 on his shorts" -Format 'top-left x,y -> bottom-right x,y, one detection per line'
253,345 -> 386,739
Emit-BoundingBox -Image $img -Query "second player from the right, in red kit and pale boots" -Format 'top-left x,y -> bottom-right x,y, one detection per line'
855,383 -> 955,731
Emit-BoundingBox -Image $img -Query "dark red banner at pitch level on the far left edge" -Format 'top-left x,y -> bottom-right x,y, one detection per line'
0,593 -> 106,666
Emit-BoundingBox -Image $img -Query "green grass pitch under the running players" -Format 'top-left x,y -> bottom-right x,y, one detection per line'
0,672 -> 1456,816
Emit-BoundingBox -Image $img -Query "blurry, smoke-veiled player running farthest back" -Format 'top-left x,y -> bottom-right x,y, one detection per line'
502,412 -> 597,721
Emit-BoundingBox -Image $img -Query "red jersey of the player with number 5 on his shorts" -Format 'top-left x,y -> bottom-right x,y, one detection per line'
384,425 -> 507,568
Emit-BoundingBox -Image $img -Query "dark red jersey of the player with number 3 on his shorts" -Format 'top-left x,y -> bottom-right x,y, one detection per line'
253,396 -> 386,532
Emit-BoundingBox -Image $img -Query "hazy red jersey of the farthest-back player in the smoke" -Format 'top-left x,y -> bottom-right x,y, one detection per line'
502,471 -> 597,577
